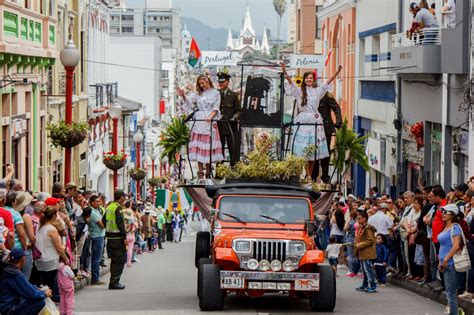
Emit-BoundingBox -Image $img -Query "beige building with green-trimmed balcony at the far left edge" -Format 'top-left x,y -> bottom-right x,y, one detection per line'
0,0 -> 58,191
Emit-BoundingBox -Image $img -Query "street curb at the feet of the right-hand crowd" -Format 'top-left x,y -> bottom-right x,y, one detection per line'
387,277 -> 474,314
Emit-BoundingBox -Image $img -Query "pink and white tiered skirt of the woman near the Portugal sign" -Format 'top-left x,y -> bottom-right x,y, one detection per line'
189,122 -> 224,164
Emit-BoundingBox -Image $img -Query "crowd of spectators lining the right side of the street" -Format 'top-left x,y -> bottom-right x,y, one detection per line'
316,177 -> 474,315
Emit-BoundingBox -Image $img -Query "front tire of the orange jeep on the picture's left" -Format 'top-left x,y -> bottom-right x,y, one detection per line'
199,264 -> 224,311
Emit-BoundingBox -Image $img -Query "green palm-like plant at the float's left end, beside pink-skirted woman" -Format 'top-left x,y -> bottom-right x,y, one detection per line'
158,116 -> 190,164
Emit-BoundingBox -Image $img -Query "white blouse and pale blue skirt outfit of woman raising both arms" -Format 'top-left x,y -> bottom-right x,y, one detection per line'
285,81 -> 329,161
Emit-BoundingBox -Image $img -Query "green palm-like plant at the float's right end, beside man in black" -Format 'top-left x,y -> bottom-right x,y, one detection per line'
333,119 -> 369,184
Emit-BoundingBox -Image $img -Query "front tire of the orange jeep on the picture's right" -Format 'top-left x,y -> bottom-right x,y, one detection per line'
309,266 -> 336,312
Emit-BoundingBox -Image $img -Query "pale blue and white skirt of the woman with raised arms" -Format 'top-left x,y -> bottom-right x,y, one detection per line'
291,112 -> 329,161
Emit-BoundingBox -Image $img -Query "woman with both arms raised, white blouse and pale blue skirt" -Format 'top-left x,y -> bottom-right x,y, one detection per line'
281,63 -> 342,177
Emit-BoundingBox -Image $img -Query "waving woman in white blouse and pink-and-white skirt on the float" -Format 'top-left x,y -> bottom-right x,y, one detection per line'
177,74 -> 224,178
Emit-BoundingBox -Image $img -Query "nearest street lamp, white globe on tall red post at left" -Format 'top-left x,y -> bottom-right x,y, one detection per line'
59,36 -> 81,184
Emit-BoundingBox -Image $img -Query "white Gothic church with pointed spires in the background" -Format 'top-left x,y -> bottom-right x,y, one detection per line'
226,7 -> 270,58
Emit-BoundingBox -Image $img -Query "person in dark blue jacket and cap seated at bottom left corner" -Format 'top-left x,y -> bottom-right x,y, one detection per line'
0,248 -> 52,315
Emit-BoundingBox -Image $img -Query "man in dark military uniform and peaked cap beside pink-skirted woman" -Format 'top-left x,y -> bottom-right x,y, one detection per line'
217,71 -> 242,165
